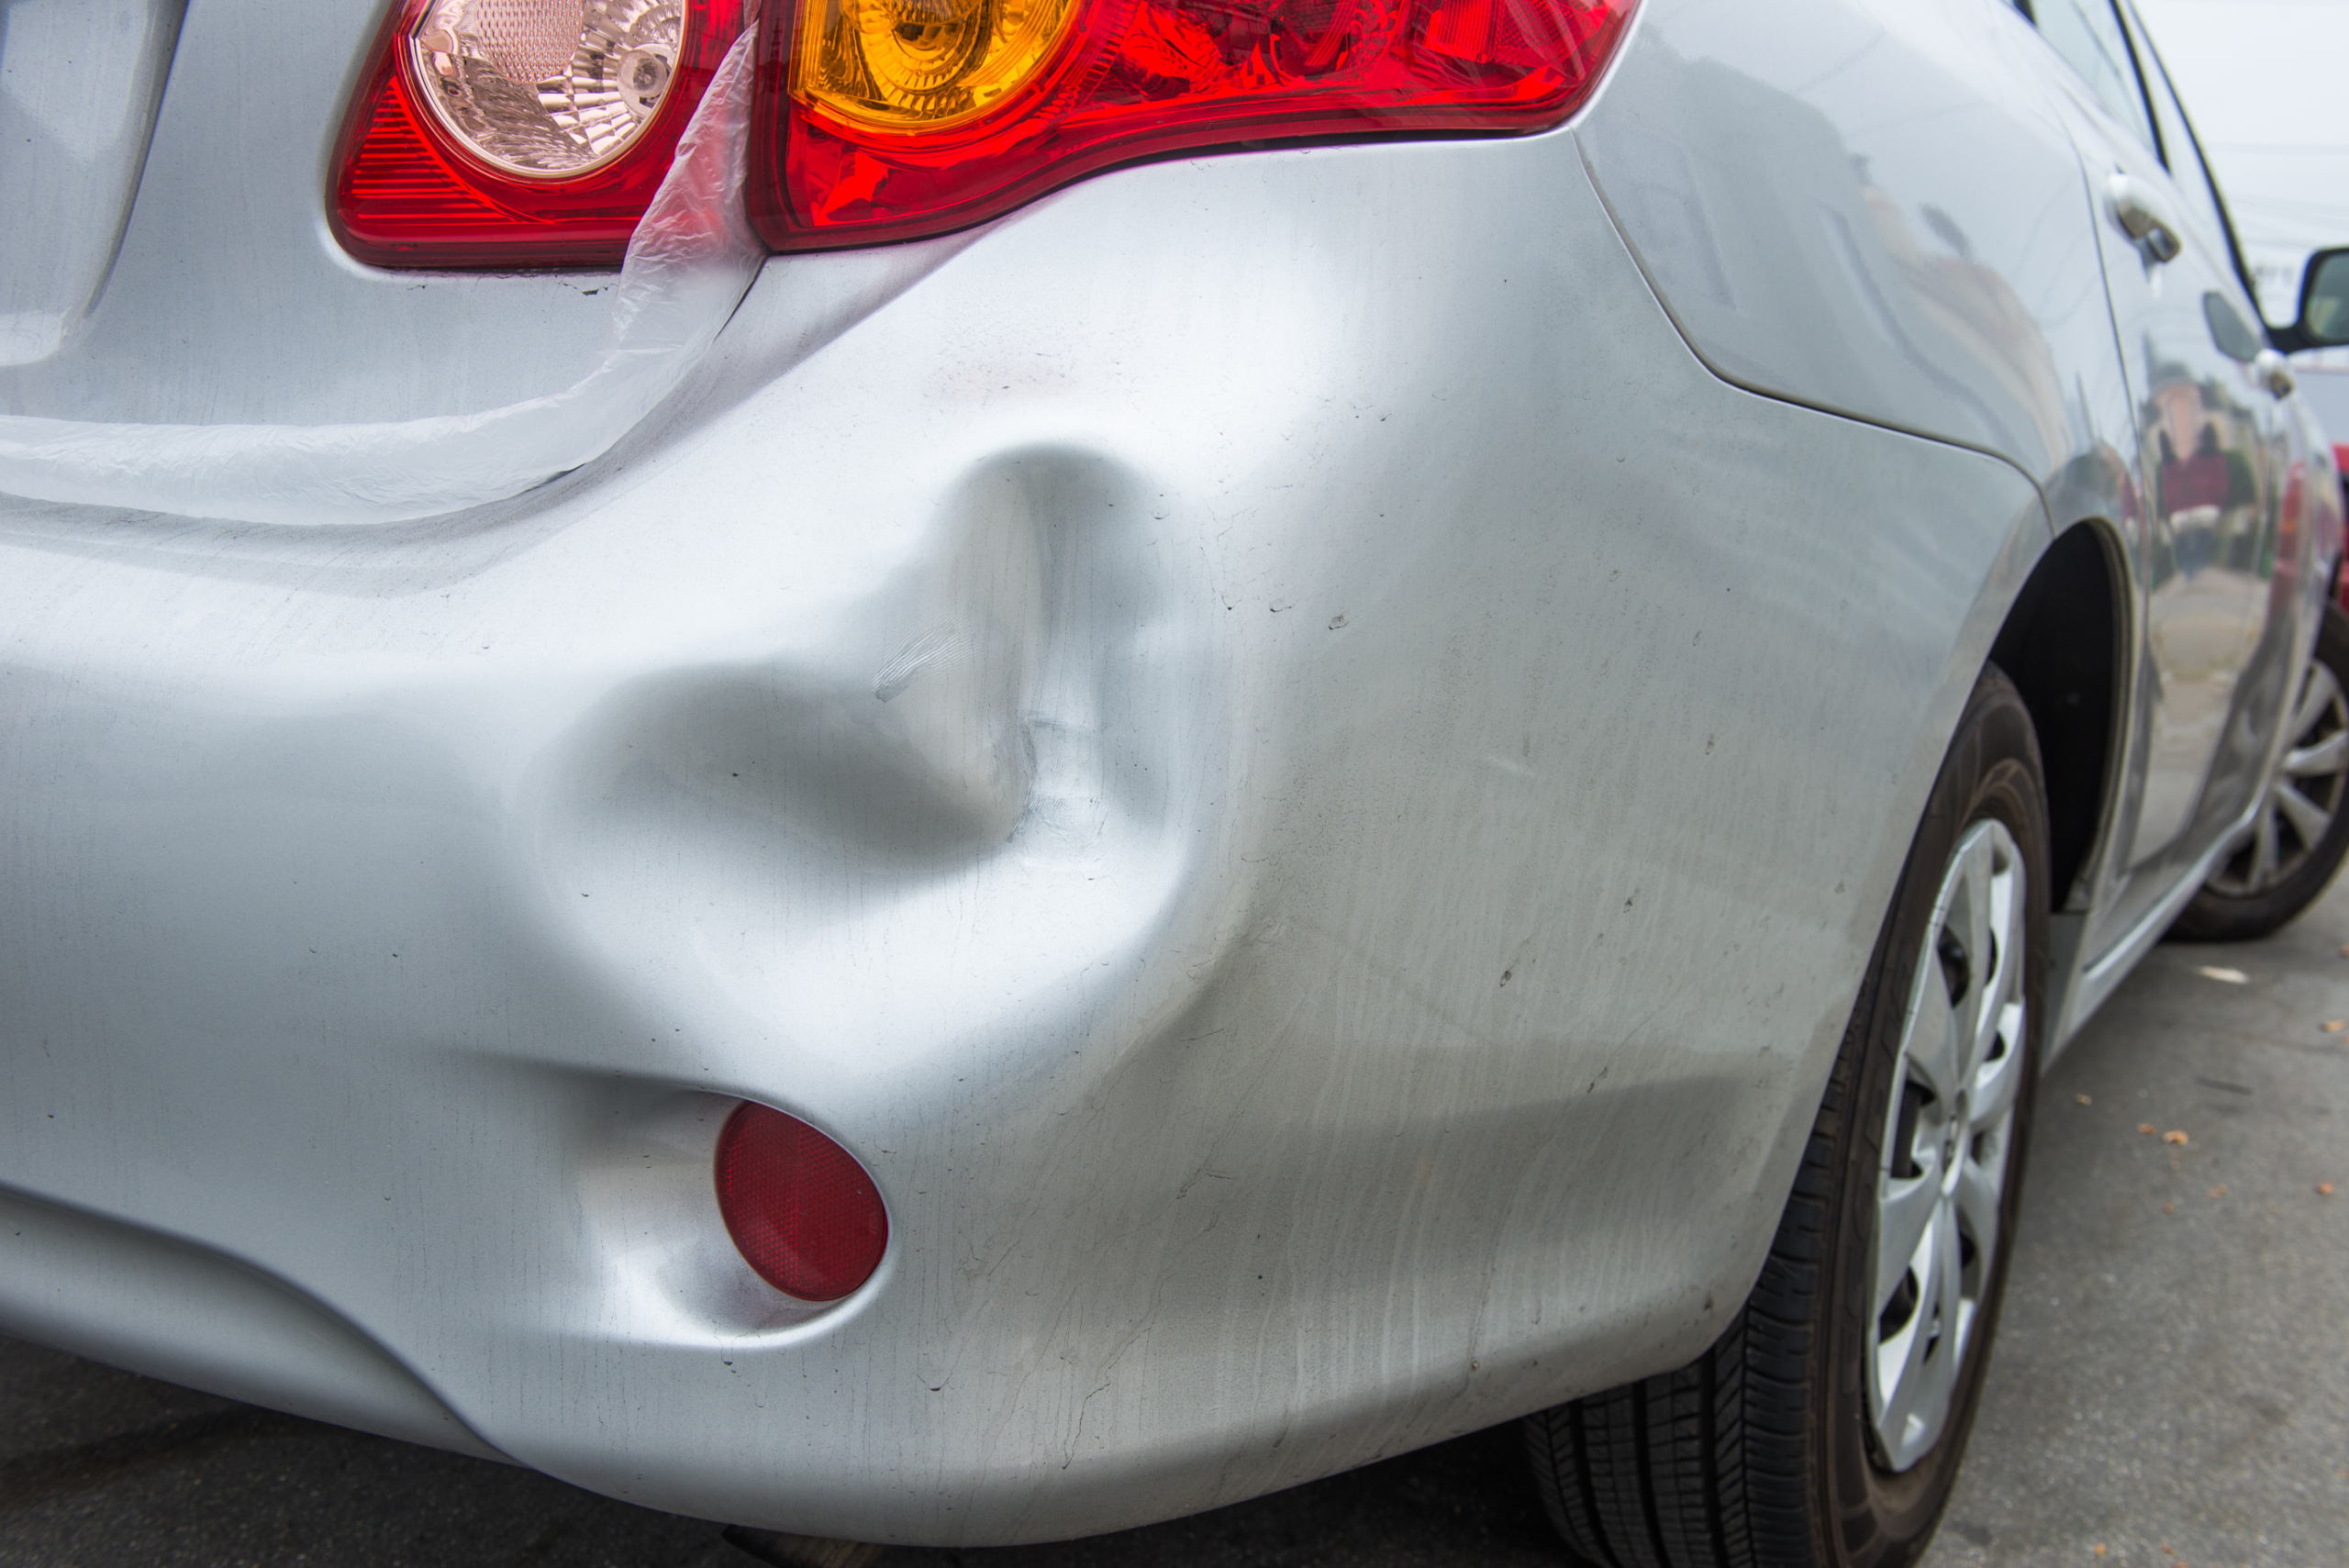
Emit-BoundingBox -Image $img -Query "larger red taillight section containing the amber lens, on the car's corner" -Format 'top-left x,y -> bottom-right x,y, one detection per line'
750,0 -> 1635,251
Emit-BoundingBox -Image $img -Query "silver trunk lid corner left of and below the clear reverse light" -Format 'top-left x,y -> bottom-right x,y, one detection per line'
0,0 -> 611,425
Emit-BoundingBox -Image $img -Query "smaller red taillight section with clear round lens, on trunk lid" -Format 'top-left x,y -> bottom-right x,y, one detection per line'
331,0 -> 745,268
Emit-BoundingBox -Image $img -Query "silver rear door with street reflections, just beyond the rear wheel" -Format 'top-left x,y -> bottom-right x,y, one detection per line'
2032,0 -> 2281,928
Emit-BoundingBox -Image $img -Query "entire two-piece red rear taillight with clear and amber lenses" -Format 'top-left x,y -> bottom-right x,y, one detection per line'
334,0 -> 1635,268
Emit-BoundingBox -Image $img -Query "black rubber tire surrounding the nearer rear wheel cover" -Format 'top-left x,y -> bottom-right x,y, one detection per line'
1524,667 -> 2048,1568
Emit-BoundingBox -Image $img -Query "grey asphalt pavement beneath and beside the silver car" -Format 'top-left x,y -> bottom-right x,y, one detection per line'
0,885 -> 2349,1568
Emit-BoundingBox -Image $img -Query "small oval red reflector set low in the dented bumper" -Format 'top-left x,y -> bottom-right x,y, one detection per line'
717,1103 -> 888,1300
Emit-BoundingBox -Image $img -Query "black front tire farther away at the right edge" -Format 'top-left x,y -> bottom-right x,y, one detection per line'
2170,604 -> 2349,941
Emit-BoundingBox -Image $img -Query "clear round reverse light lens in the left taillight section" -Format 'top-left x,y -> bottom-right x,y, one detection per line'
408,0 -> 686,178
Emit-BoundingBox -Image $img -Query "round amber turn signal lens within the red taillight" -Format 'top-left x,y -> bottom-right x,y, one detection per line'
792,0 -> 1074,131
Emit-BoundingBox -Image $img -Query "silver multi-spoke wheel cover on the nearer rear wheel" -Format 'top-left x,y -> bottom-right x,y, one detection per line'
1867,821 -> 2030,1472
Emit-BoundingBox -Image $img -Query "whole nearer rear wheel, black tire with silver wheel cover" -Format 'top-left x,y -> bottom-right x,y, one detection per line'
1524,667 -> 2048,1568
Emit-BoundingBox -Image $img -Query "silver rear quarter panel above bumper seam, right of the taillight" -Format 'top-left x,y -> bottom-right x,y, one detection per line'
1583,0 -> 2119,484
